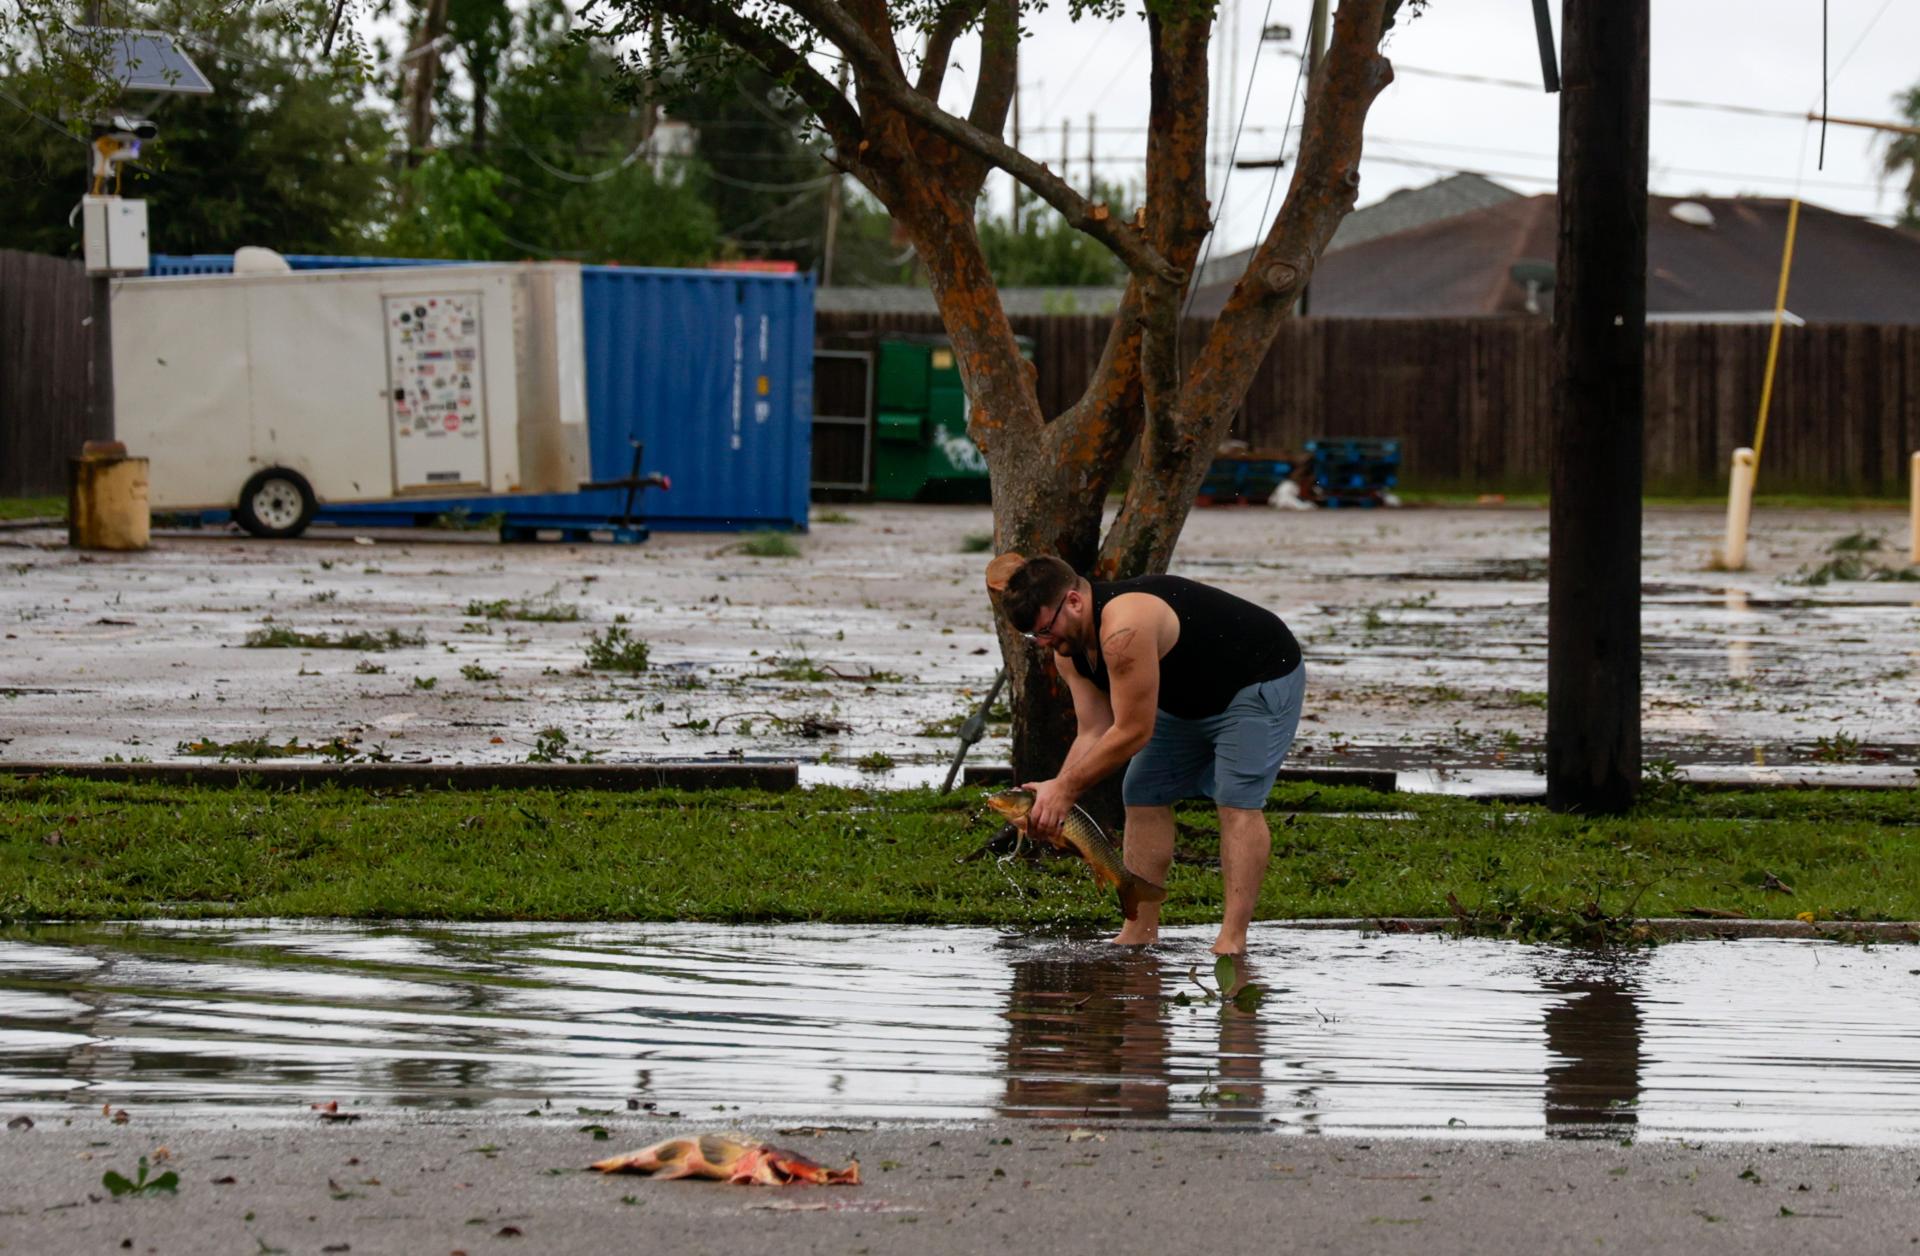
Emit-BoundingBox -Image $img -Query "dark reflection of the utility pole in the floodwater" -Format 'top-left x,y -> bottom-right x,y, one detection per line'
1540,954 -> 1642,1139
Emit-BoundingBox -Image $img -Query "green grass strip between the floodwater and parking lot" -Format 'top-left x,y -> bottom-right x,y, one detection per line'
0,776 -> 1920,939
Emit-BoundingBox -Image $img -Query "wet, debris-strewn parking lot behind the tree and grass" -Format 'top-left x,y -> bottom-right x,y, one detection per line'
0,505 -> 1920,787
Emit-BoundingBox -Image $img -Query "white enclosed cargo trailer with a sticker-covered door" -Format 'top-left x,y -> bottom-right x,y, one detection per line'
113,263 -> 591,536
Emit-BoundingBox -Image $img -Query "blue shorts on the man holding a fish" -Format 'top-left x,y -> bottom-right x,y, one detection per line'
1119,676 -> 1308,810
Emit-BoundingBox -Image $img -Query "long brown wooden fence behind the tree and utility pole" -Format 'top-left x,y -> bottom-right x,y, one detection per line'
816,313 -> 1920,494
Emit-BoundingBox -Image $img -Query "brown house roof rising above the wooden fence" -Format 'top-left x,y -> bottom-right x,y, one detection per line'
1194,194 -> 1920,323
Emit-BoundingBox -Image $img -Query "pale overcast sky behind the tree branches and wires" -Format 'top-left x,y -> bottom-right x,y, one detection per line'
925,0 -> 1920,252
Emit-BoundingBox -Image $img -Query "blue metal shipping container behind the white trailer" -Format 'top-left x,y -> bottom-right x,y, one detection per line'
152,254 -> 814,532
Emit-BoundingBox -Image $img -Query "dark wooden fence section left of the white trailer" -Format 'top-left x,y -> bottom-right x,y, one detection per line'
0,250 -> 92,497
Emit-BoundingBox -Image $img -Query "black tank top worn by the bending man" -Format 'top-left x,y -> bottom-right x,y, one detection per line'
1073,576 -> 1300,720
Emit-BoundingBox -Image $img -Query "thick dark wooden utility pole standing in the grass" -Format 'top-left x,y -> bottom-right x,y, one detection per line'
1548,0 -> 1649,814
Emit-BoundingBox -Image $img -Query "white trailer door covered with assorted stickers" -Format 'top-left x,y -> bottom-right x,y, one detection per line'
384,292 -> 488,494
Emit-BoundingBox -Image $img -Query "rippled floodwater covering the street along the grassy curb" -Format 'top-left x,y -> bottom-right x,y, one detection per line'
0,922 -> 1920,1145
